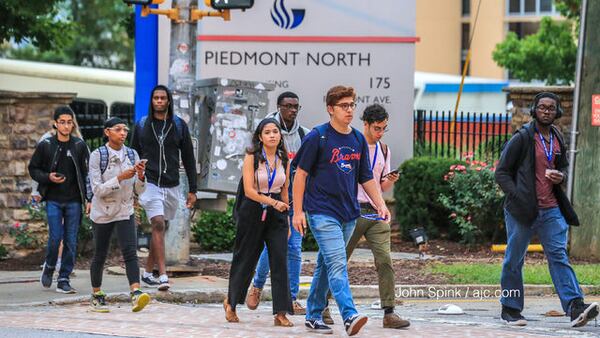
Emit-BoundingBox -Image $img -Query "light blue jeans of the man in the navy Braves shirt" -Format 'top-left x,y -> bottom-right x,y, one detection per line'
306,213 -> 358,321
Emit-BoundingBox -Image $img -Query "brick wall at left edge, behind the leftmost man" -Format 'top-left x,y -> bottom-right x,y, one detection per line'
0,91 -> 75,255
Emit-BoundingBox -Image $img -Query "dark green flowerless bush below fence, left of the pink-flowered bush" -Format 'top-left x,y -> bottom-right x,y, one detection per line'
394,157 -> 464,239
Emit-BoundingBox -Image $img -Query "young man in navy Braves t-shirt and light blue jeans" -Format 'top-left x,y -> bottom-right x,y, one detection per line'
293,86 -> 390,336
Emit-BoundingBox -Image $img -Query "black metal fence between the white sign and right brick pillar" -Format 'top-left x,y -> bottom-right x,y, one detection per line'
414,110 -> 512,161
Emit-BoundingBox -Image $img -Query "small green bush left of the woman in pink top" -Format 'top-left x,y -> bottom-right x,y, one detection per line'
192,200 -> 236,251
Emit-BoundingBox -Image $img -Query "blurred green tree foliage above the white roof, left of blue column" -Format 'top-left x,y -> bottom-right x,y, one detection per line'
2,0 -> 134,70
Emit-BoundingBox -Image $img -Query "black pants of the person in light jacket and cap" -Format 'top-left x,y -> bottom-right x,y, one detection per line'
90,215 -> 140,288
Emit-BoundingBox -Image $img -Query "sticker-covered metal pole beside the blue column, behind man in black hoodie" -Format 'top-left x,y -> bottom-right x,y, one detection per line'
165,0 -> 197,265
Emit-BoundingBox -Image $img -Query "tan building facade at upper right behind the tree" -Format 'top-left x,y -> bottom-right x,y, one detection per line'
416,0 -> 561,79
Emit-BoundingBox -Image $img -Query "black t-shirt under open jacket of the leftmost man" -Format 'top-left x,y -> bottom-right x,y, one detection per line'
46,142 -> 81,203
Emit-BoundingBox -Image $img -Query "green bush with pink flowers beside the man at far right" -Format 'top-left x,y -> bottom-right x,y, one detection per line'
438,161 -> 504,244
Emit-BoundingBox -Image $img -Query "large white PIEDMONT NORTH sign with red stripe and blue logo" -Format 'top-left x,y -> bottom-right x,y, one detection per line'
196,0 -> 418,166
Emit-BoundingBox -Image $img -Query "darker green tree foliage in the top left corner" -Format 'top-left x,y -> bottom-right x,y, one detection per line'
0,0 -> 73,51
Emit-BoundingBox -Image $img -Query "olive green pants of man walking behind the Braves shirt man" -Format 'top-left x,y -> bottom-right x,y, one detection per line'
346,208 -> 395,308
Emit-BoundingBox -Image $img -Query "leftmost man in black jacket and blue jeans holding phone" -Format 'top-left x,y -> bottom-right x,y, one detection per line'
29,106 -> 92,293
